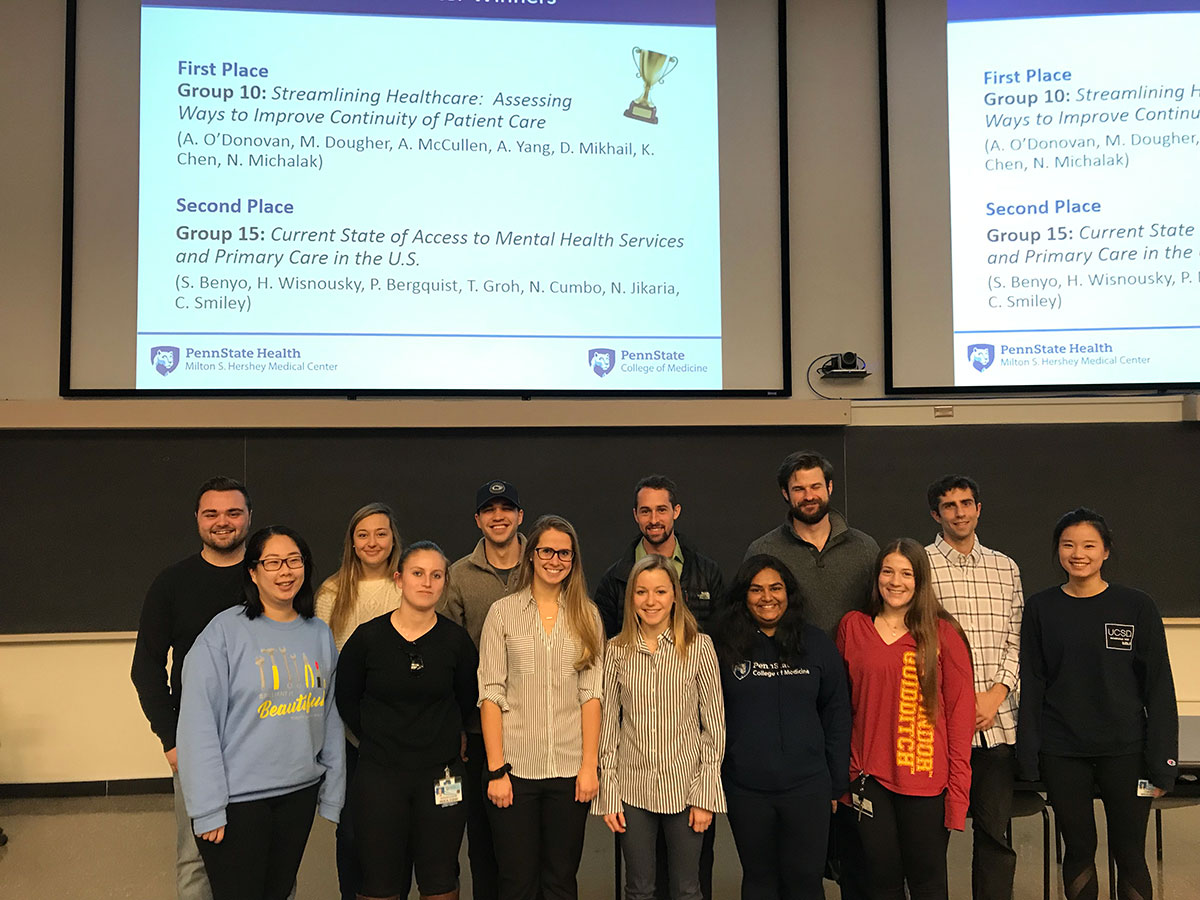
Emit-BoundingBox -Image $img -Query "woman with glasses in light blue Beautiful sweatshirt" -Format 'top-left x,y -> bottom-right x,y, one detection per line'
178,526 -> 346,900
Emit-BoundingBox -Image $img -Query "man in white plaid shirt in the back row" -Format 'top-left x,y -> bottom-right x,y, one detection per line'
925,475 -> 1025,900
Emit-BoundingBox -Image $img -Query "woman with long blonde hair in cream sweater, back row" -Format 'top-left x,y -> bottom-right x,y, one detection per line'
316,503 -> 401,900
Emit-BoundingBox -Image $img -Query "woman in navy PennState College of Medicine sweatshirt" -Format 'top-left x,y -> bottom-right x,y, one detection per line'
713,554 -> 850,900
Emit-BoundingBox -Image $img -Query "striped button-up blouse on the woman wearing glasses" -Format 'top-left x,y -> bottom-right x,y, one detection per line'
479,588 -> 604,779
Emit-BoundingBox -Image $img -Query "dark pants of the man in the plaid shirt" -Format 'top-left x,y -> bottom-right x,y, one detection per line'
971,744 -> 1016,900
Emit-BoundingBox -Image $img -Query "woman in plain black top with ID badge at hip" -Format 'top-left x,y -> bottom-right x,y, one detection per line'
336,541 -> 479,900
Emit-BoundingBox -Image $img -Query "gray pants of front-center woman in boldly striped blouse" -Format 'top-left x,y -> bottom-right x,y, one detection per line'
620,803 -> 700,900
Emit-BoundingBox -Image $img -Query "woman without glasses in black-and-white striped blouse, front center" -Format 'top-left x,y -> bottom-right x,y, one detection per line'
592,554 -> 725,900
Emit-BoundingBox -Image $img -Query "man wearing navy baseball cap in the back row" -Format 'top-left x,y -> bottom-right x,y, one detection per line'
439,479 -> 526,900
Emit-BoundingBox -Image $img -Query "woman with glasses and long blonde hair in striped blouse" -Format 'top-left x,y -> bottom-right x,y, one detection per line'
479,516 -> 604,900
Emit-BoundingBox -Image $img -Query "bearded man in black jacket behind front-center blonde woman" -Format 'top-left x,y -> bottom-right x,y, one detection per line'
593,475 -> 725,637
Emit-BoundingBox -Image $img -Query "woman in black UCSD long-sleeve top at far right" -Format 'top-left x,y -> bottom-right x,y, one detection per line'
1016,508 -> 1178,900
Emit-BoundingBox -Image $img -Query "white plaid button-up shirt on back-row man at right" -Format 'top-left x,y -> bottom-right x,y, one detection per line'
925,534 -> 1025,746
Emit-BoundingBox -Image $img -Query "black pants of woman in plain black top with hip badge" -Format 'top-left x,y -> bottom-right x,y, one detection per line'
350,758 -> 467,896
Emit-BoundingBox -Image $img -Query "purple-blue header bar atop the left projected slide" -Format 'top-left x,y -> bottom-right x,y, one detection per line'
142,0 -> 716,25
